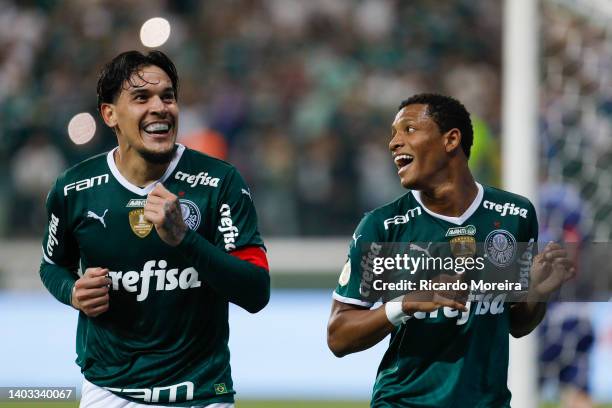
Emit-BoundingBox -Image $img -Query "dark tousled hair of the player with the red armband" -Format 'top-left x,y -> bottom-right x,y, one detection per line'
97,51 -> 178,110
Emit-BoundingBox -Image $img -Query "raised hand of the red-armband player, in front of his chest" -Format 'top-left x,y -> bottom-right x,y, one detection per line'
144,183 -> 187,246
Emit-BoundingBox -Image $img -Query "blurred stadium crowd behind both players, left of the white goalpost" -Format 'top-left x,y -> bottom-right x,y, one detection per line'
0,0 -> 501,237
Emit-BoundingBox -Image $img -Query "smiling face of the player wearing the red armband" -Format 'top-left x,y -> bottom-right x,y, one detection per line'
100,65 -> 179,164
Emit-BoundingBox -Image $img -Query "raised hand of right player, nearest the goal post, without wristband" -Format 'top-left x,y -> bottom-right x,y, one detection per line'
529,242 -> 576,301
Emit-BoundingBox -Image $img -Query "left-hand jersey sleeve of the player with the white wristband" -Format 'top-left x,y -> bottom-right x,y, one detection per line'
333,213 -> 382,307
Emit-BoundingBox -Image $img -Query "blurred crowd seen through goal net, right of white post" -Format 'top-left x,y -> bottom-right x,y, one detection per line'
541,0 -> 612,242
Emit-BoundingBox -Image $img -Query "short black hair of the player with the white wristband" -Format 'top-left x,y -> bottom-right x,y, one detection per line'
397,93 -> 474,158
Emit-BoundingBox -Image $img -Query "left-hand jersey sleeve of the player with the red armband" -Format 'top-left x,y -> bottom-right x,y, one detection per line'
40,181 -> 79,304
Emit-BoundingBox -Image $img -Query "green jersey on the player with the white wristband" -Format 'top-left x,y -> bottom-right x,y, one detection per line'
333,184 -> 538,408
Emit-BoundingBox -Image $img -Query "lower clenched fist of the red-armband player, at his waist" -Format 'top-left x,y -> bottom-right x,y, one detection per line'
71,268 -> 111,317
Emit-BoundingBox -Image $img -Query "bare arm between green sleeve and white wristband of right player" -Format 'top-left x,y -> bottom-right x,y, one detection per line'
327,306 -> 395,357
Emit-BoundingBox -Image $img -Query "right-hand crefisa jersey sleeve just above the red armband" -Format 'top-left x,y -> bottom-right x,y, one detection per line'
213,168 -> 264,252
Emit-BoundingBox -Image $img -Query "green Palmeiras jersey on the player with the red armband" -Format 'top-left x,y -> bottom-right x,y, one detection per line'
43,145 -> 263,406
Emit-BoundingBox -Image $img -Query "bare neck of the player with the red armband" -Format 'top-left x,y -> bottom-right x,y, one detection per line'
114,144 -> 170,187
